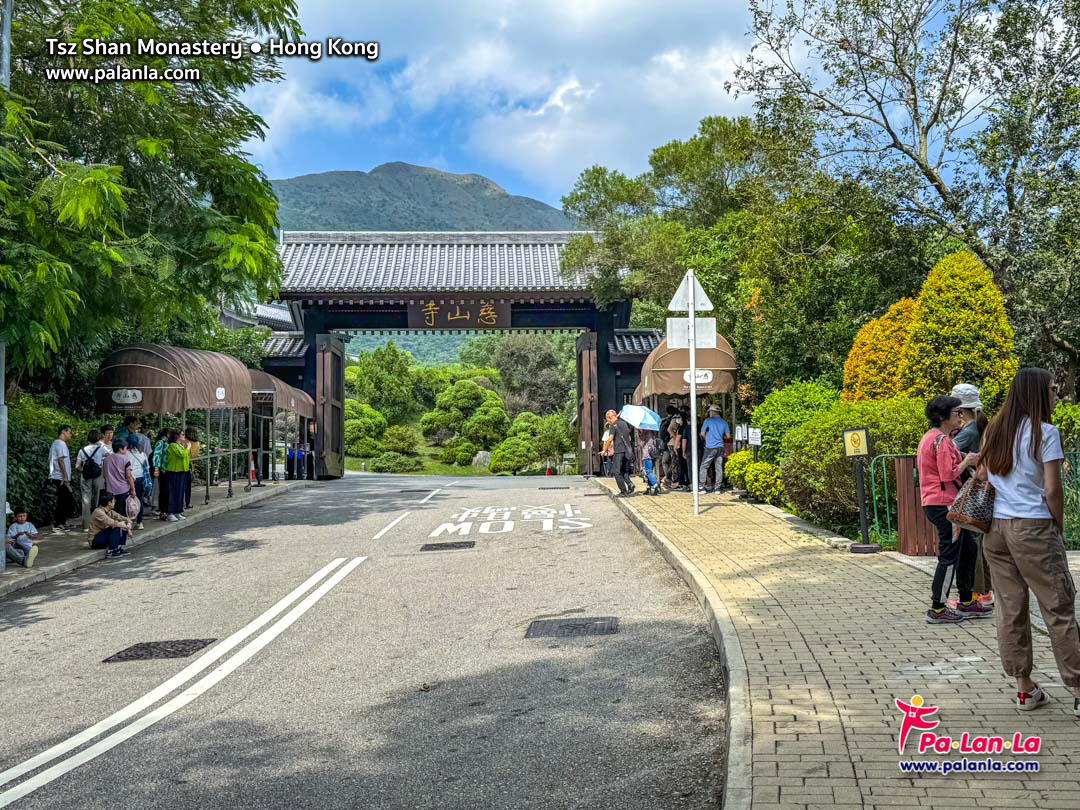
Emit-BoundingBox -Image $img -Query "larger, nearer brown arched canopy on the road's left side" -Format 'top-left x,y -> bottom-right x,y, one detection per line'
94,343 -> 252,414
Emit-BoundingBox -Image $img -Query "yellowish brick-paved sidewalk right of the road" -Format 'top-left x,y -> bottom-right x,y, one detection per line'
597,480 -> 1080,810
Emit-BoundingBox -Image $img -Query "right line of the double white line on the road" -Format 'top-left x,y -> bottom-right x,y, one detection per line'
0,557 -> 367,807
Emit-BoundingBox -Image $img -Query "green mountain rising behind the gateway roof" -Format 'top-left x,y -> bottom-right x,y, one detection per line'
271,163 -> 573,231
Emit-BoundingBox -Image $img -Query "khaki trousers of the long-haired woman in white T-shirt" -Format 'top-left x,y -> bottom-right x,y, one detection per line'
983,518 -> 1080,687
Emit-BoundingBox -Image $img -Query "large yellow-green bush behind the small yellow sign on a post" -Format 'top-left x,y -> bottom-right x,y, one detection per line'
780,396 -> 927,530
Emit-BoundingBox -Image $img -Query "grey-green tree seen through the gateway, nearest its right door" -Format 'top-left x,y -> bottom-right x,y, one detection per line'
491,335 -> 570,414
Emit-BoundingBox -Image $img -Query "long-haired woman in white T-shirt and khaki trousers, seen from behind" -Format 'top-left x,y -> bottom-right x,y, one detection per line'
980,368 -> 1080,717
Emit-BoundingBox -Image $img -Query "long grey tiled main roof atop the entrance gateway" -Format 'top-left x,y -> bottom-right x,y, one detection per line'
280,231 -> 585,296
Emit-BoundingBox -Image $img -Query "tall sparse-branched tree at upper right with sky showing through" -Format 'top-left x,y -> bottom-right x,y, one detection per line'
734,0 -> 1080,392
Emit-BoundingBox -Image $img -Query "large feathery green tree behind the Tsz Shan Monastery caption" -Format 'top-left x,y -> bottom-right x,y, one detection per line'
0,0 -> 301,372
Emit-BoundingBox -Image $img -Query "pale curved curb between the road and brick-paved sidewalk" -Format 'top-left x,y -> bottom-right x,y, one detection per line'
593,481 -> 754,810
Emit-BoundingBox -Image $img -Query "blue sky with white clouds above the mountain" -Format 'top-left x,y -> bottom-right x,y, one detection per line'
247,0 -> 748,205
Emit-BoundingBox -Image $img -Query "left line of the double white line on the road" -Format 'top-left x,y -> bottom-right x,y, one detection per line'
0,557 -> 346,794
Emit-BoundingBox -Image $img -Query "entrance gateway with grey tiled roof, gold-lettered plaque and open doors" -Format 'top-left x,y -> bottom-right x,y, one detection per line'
280,231 -> 637,477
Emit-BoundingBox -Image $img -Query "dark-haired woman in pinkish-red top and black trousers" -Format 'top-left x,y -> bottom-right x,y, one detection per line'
916,396 -> 994,624
